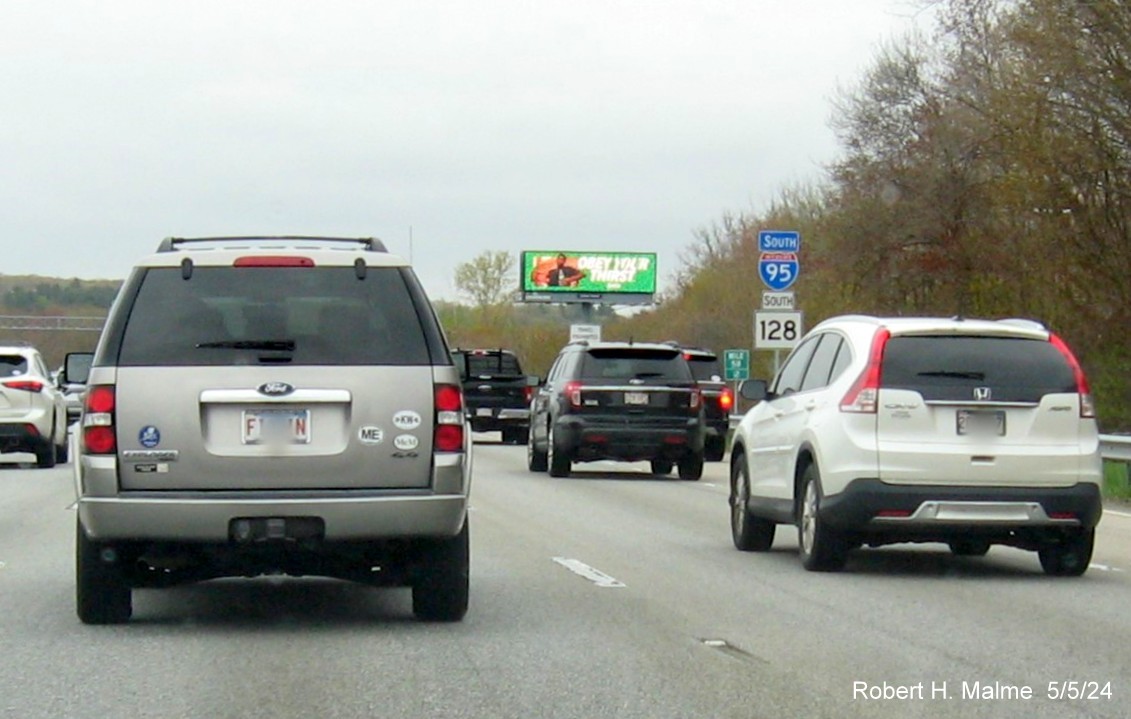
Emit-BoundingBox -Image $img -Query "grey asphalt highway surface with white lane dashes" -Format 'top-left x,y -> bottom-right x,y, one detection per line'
0,434 -> 1131,719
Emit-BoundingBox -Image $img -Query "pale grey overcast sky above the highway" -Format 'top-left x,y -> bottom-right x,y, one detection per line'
0,0 -> 914,300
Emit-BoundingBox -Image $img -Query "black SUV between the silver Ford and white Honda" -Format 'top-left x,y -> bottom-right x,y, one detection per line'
527,343 -> 703,480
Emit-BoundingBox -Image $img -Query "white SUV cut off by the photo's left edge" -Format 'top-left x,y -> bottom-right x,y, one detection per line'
0,345 -> 67,469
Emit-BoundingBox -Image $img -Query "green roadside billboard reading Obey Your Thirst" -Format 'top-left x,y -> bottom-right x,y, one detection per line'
519,250 -> 656,304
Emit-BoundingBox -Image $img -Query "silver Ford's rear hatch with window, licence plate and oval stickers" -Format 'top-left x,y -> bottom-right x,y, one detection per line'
106,266 -> 435,491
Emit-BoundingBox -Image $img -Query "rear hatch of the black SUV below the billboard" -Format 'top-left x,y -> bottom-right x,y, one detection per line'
571,346 -> 700,427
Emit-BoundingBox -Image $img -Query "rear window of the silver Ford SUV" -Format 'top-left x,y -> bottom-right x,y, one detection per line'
118,267 -> 429,366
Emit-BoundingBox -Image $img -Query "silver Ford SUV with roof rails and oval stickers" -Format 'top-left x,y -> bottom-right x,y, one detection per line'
74,236 -> 472,624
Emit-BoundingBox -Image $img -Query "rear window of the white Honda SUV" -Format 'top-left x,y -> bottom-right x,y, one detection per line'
880,337 -> 1077,402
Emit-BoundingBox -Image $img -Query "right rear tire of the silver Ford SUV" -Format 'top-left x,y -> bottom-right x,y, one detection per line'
413,517 -> 472,622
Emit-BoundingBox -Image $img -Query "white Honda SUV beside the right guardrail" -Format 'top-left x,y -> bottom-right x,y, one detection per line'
731,315 -> 1103,575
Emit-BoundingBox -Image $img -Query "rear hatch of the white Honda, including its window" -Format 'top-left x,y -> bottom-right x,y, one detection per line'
877,335 -> 1096,486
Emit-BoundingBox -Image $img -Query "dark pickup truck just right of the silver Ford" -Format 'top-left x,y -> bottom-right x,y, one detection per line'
451,348 -> 538,444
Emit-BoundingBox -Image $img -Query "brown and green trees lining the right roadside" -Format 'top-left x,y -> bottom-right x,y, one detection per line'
448,0 -> 1131,432
